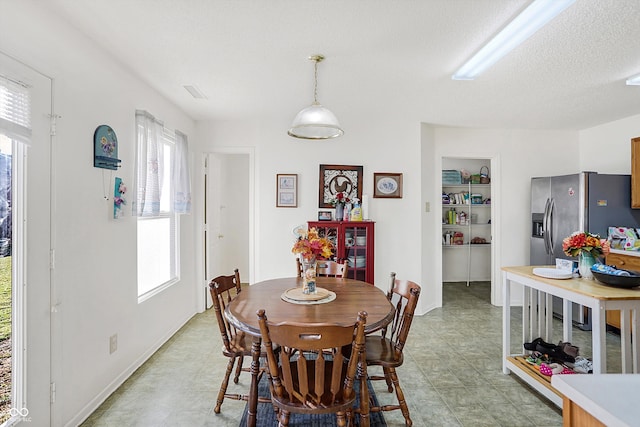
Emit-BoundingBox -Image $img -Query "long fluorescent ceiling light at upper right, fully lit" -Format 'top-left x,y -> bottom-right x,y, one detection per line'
451,0 -> 575,80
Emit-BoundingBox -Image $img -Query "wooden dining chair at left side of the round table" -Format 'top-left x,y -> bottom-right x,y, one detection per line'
209,268 -> 271,414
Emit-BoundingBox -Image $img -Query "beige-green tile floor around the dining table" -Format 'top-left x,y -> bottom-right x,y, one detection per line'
82,282 -> 620,427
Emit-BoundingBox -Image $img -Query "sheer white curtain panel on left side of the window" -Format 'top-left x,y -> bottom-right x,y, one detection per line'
133,110 -> 164,216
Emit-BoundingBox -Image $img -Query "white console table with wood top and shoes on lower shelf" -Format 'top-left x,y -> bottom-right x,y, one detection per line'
502,266 -> 640,407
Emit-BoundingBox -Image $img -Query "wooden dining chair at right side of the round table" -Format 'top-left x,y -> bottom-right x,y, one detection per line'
365,273 -> 420,426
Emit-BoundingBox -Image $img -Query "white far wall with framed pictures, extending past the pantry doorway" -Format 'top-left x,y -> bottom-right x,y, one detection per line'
192,120 -> 579,313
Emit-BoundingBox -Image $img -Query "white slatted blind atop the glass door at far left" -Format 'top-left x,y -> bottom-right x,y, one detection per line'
0,76 -> 31,142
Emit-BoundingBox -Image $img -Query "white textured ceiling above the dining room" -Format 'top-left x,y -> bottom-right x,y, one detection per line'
43,0 -> 640,129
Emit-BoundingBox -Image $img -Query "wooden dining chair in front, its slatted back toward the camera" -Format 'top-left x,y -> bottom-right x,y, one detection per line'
258,310 -> 367,427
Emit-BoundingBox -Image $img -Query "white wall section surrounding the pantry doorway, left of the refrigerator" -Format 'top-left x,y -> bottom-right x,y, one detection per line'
423,126 -> 579,306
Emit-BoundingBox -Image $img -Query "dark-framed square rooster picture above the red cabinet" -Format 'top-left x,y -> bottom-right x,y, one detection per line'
318,165 -> 362,208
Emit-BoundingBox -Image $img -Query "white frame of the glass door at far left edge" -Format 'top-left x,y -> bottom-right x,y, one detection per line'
0,52 -> 53,425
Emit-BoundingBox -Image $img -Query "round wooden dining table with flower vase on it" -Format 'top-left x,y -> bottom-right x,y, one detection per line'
224,277 -> 395,427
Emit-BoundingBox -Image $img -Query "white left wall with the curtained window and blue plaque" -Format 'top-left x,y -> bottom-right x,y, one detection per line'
0,2 -> 196,425
